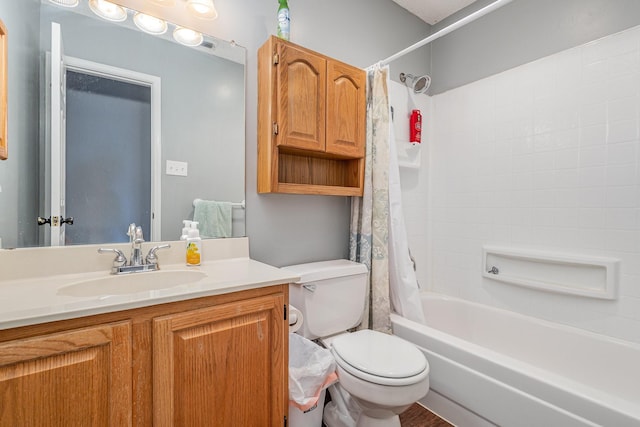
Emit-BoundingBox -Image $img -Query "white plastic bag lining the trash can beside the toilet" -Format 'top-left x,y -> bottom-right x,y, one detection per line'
289,334 -> 338,411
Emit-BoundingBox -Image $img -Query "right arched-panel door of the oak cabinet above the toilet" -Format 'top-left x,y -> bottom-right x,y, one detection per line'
326,61 -> 366,158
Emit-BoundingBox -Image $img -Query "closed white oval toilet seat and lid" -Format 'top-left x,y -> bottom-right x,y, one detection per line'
331,329 -> 429,386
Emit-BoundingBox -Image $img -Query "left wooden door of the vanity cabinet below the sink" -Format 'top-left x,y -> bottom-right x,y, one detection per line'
0,322 -> 132,427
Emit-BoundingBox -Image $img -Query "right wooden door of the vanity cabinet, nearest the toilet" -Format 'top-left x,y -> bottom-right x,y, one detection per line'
153,294 -> 288,427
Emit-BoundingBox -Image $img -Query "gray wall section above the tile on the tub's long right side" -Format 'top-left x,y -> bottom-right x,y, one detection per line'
431,0 -> 640,94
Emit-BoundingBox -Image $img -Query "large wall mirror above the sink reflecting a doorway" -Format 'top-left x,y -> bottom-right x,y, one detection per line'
0,0 -> 246,248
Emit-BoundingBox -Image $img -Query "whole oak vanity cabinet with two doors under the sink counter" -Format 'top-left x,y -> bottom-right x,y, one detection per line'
0,285 -> 289,427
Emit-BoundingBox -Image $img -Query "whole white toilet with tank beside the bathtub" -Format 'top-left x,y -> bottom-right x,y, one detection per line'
283,260 -> 429,427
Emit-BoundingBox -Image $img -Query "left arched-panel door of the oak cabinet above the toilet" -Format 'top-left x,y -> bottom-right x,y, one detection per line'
276,44 -> 327,152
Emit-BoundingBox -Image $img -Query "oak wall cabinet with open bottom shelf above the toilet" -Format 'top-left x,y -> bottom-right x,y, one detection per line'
258,36 -> 366,196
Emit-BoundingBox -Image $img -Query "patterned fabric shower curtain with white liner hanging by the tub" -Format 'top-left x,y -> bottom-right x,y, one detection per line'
349,65 -> 424,333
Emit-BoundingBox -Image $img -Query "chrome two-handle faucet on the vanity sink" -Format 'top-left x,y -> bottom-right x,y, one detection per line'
98,224 -> 171,274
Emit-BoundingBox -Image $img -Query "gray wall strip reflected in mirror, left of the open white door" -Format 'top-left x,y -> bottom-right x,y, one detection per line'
0,0 -> 40,247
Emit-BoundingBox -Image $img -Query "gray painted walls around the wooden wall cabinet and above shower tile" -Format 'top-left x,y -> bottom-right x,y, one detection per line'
239,0 -> 640,265
